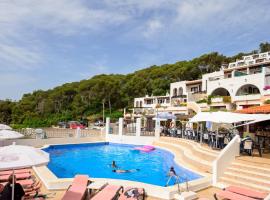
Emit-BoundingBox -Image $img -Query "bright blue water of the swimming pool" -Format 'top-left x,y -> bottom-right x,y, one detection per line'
44,143 -> 201,186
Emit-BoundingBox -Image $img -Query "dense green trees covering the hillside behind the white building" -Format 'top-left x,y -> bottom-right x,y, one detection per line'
0,43 -> 270,127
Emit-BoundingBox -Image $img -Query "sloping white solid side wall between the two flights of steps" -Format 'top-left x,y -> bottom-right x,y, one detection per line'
213,135 -> 240,185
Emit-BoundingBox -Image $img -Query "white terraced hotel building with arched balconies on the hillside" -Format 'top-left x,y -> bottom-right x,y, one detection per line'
127,52 -> 270,119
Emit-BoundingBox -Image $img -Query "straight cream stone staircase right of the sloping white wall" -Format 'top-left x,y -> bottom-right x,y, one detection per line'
218,156 -> 270,193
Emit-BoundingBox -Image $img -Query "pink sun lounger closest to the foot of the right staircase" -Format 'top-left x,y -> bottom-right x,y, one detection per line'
225,186 -> 268,199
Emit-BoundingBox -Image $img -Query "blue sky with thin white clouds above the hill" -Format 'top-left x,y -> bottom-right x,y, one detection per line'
0,0 -> 270,100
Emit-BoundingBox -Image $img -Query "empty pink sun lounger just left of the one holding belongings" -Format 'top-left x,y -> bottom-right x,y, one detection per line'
91,184 -> 123,200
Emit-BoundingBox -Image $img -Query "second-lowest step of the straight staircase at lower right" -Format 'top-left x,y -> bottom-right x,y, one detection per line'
223,171 -> 270,188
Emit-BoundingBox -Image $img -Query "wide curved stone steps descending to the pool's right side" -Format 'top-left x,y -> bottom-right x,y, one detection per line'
154,137 -> 218,173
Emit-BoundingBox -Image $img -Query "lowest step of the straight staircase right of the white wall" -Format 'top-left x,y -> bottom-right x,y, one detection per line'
219,177 -> 270,193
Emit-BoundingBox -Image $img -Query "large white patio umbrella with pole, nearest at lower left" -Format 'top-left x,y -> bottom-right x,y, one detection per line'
0,145 -> 50,200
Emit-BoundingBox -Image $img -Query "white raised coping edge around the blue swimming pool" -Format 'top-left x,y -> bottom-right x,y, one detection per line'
36,141 -> 212,199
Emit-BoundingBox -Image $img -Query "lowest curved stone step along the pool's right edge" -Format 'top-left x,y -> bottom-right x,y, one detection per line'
154,141 -> 212,173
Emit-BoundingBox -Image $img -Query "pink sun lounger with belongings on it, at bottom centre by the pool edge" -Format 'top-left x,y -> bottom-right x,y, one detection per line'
118,187 -> 145,200
